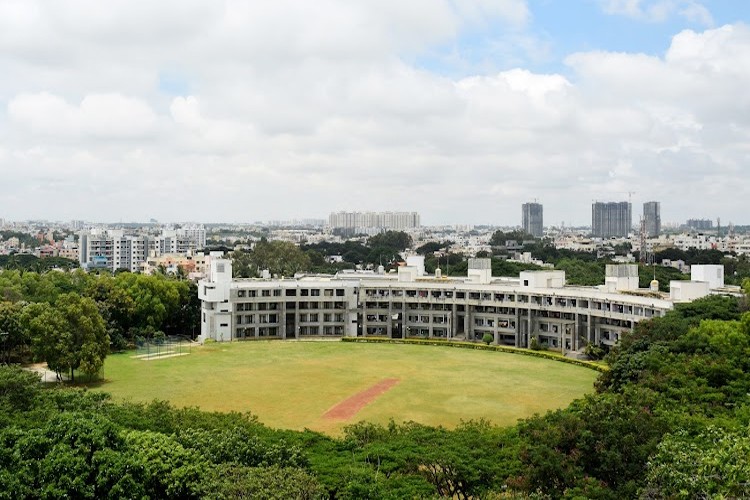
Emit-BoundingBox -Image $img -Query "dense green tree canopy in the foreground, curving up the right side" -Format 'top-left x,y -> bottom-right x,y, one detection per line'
0,283 -> 750,499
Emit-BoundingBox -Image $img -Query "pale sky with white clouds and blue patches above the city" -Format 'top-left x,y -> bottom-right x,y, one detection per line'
0,0 -> 750,226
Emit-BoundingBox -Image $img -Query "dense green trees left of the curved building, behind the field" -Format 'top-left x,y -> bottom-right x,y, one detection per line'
0,269 -> 200,376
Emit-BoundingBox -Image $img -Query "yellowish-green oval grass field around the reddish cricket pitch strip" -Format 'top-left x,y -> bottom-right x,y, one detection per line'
93,341 -> 597,434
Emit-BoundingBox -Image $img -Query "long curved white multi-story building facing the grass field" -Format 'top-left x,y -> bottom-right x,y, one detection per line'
198,259 -> 709,351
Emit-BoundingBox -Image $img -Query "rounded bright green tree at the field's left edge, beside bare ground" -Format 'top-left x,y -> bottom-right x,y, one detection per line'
23,294 -> 109,381
